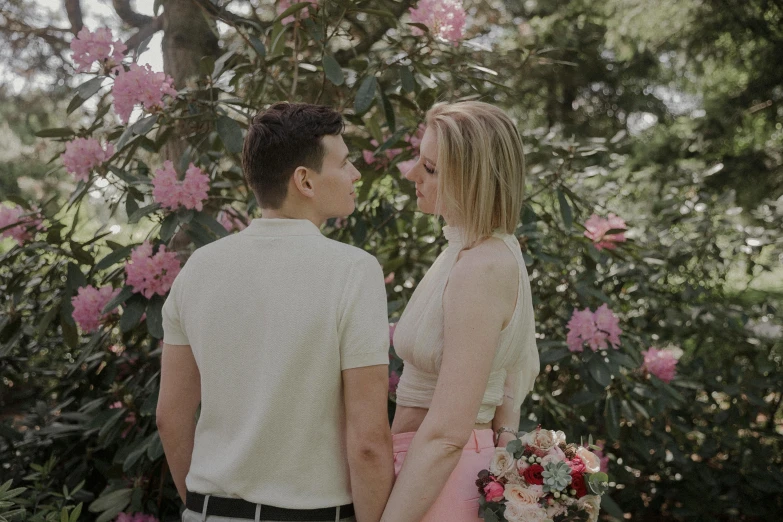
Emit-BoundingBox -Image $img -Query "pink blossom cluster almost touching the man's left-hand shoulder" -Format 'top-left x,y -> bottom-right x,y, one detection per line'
125,241 -> 181,299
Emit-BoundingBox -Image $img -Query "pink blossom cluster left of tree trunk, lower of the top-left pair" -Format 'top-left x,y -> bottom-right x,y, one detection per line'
112,63 -> 177,123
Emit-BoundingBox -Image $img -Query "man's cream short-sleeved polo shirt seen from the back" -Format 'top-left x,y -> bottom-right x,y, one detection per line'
163,219 -> 389,509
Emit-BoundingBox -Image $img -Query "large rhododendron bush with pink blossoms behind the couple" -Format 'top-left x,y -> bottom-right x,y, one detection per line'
0,0 -> 783,522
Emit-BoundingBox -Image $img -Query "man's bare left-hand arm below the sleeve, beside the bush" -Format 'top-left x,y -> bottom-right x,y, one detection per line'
156,343 -> 201,502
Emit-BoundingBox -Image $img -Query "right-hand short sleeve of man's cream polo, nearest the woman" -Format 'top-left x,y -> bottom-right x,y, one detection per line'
338,257 -> 389,370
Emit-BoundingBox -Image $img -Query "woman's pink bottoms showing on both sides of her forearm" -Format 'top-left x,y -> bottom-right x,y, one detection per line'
392,430 -> 495,522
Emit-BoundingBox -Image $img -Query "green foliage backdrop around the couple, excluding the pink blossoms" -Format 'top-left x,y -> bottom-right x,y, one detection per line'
0,0 -> 783,521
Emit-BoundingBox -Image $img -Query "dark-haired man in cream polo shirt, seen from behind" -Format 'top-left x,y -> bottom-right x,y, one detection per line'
157,103 -> 394,522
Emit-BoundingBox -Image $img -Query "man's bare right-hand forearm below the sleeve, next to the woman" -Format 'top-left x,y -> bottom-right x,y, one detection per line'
342,364 -> 394,522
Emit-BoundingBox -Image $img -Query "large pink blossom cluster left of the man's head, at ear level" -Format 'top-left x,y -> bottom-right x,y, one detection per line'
152,161 -> 209,210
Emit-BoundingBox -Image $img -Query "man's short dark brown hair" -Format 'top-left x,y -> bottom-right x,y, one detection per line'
242,102 -> 344,209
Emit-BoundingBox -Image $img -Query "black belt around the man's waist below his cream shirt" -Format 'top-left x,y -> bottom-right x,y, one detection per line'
185,491 -> 354,522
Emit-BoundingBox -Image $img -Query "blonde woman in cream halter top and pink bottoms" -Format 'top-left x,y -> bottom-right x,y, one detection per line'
381,102 -> 539,522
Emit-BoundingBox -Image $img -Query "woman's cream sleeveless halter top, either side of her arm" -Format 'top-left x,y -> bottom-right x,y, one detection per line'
394,223 -> 540,424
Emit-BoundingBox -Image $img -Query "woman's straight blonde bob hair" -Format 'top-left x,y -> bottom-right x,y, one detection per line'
426,101 -> 525,246
